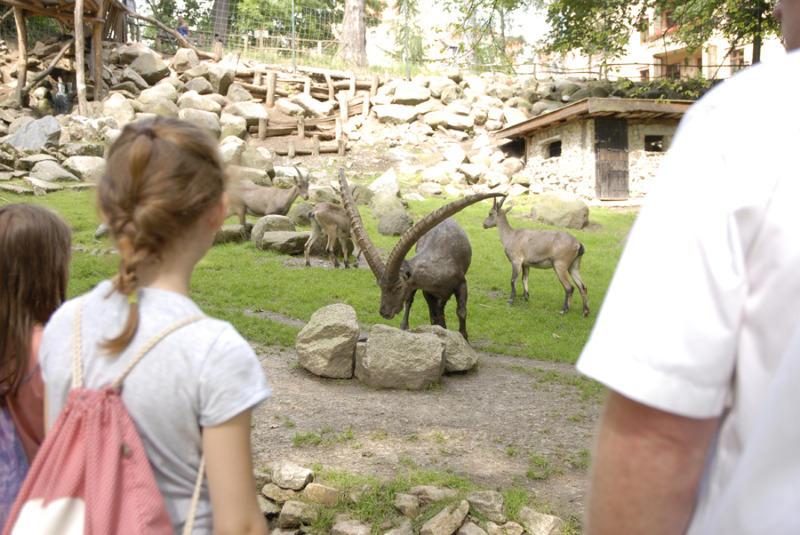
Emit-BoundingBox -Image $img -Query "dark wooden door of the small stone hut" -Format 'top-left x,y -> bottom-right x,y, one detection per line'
594,117 -> 628,201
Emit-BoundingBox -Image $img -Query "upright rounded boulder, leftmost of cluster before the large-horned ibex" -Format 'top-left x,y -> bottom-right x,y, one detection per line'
295,303 -> 360,379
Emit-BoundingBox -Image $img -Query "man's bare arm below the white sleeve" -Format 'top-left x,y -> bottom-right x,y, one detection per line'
586,391 -> 718,535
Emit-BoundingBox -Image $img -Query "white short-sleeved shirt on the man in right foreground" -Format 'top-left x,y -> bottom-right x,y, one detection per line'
578,48 -> 800,535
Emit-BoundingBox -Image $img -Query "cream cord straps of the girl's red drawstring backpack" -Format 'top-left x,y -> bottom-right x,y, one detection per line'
72,297 -> 206,535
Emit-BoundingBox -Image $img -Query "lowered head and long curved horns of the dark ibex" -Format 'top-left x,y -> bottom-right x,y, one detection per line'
339,168 -> 502,319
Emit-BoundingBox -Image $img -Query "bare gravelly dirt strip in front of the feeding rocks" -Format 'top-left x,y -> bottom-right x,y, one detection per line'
247,346 -> 602,518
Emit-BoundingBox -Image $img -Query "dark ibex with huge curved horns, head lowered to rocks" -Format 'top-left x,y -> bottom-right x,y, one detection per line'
339,168 -> 502,339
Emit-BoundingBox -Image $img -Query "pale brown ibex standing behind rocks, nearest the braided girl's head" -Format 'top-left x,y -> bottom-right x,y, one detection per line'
228,166 -> 308,226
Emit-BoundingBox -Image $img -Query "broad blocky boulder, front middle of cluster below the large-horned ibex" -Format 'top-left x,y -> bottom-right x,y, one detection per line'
356,324 -> 444,390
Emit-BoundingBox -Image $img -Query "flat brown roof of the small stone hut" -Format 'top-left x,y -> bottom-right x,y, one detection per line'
493,98 -> 694,138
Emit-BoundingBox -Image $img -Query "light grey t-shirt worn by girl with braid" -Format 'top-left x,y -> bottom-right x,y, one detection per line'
40,281 -> 270,533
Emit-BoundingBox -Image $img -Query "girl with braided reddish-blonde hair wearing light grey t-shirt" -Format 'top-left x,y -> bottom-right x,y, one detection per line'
40,117 -> 270,534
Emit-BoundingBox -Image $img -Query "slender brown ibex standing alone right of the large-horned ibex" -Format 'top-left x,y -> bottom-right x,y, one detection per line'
483,196 -> 589,316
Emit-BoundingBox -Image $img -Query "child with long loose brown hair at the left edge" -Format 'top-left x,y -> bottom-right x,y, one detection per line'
0,204 -> 71,526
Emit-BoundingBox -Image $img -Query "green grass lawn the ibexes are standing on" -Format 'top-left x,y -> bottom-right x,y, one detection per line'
0,187 -> 636,364
